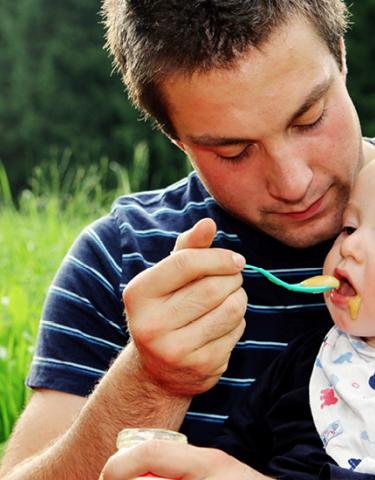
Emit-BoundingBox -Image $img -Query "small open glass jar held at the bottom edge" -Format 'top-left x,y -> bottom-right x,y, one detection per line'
116,428 -> 187,480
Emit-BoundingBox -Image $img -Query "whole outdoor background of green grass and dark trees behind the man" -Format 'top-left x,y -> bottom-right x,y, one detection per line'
0,0 -> 375,455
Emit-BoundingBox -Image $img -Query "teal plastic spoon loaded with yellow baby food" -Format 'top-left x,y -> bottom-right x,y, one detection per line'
244,264 -> 340,293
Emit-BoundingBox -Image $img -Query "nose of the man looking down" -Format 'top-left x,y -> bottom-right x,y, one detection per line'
265,143 -> 313,203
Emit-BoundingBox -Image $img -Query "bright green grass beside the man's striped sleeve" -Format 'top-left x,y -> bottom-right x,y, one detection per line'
0,159 -> 129,448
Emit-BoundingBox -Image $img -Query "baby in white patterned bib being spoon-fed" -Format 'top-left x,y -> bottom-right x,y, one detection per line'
310,157 -> 375,474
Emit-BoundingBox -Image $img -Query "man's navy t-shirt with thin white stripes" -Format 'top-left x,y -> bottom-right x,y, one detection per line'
27,172 -> 331,445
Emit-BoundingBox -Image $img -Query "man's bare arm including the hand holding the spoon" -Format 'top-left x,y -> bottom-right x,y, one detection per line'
1,221 -> 247,480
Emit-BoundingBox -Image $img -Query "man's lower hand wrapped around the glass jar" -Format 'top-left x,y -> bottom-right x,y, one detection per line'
100,440 -> 269,480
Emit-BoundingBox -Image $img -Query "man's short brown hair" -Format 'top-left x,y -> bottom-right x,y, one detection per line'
102,0 -> 348,138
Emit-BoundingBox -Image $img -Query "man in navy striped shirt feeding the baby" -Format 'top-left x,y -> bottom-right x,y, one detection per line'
2,0 -> 374,480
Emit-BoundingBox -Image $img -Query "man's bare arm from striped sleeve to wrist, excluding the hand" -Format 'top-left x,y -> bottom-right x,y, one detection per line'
0,345 -> 189,480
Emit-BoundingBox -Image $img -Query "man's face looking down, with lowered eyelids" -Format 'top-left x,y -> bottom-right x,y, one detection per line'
162,15 -> 363,247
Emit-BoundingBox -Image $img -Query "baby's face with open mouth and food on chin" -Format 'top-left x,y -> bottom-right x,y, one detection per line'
324,161 -> 375,346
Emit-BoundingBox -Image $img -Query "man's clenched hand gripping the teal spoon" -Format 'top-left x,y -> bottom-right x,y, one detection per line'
124,219 -> 247,396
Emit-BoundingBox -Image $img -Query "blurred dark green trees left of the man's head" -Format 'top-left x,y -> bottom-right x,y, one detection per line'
0,0 -> 187,195
